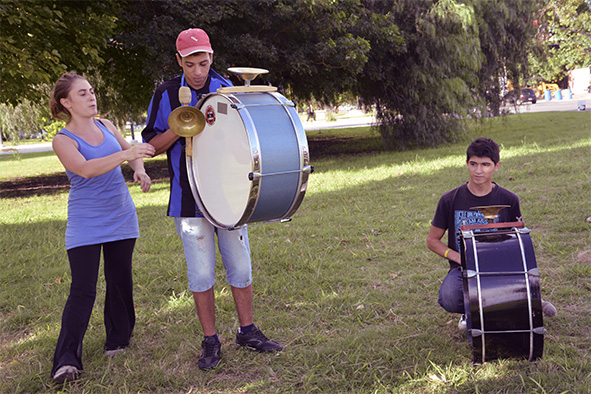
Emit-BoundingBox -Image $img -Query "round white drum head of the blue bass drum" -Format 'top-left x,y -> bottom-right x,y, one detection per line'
191,94 -> 253,228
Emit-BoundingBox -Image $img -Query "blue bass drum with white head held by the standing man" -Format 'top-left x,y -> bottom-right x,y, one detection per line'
187,91 -> 312,229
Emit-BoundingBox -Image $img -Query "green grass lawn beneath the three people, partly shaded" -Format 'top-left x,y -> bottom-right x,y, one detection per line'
0,112 -> 591,393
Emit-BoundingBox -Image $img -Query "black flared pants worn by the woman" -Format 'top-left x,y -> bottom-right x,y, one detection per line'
51,239 -> 135,376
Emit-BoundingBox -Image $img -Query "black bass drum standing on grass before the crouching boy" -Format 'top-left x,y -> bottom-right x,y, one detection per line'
461,222 -> 545,364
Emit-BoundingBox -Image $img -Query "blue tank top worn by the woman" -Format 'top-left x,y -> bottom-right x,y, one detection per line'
60,121 -> 140,250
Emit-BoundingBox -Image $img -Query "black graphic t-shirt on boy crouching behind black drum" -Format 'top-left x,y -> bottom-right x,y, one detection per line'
431,182 -> 521,267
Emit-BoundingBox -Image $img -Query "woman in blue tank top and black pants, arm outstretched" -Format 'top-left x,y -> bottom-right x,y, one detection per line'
50,73 -> 154,383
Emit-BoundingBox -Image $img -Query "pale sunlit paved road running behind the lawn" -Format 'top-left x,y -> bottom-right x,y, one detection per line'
0,93 -> 591,155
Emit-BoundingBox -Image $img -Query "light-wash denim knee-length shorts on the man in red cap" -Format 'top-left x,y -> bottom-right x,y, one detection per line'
174,217 -> 252,292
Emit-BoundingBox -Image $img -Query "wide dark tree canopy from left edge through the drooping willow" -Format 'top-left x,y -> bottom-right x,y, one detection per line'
0,0 -> 560,148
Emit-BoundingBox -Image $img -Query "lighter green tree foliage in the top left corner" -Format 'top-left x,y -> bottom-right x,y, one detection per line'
0,0 -> 116,104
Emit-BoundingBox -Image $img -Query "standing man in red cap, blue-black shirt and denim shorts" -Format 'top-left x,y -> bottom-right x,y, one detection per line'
142,29 -> 282,369
